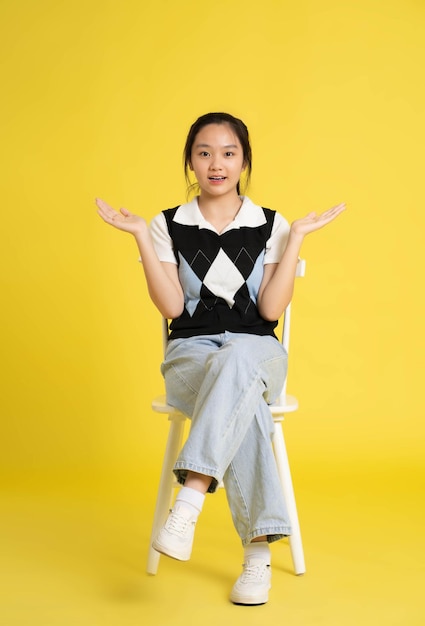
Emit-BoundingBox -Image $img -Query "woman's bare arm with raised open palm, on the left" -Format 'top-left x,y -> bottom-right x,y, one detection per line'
96,199 -> 184,319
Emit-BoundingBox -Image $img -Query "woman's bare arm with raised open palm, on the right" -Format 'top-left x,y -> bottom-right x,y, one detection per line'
257,203 -> 345,321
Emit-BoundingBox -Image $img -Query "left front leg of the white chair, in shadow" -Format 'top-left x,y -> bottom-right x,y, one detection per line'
146,413 -> 186,575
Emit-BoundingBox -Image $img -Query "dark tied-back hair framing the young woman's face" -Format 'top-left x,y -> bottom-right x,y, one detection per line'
183,113 -> 252,194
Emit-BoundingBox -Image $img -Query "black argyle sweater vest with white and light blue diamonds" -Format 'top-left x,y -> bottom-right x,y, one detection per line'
163,207 -> 277,339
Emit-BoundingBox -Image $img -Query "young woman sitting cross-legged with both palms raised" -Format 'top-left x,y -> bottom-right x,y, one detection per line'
96,113 -> 345,605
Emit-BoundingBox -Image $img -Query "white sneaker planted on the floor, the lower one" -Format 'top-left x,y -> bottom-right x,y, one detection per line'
230,557 -> 272,604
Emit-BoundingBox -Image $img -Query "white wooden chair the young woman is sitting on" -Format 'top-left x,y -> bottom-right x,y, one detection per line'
147,259 -> 305,575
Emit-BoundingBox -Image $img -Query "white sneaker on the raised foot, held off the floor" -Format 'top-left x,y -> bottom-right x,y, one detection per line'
152,507 -> 196,561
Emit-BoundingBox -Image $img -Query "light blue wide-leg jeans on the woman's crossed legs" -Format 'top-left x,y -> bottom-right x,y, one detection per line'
161,332 -> 291,545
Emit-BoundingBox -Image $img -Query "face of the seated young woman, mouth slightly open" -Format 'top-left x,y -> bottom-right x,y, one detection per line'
190,124 -> 245,196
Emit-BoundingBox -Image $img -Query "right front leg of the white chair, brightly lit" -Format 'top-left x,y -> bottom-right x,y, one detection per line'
273,422 -> 305,576
